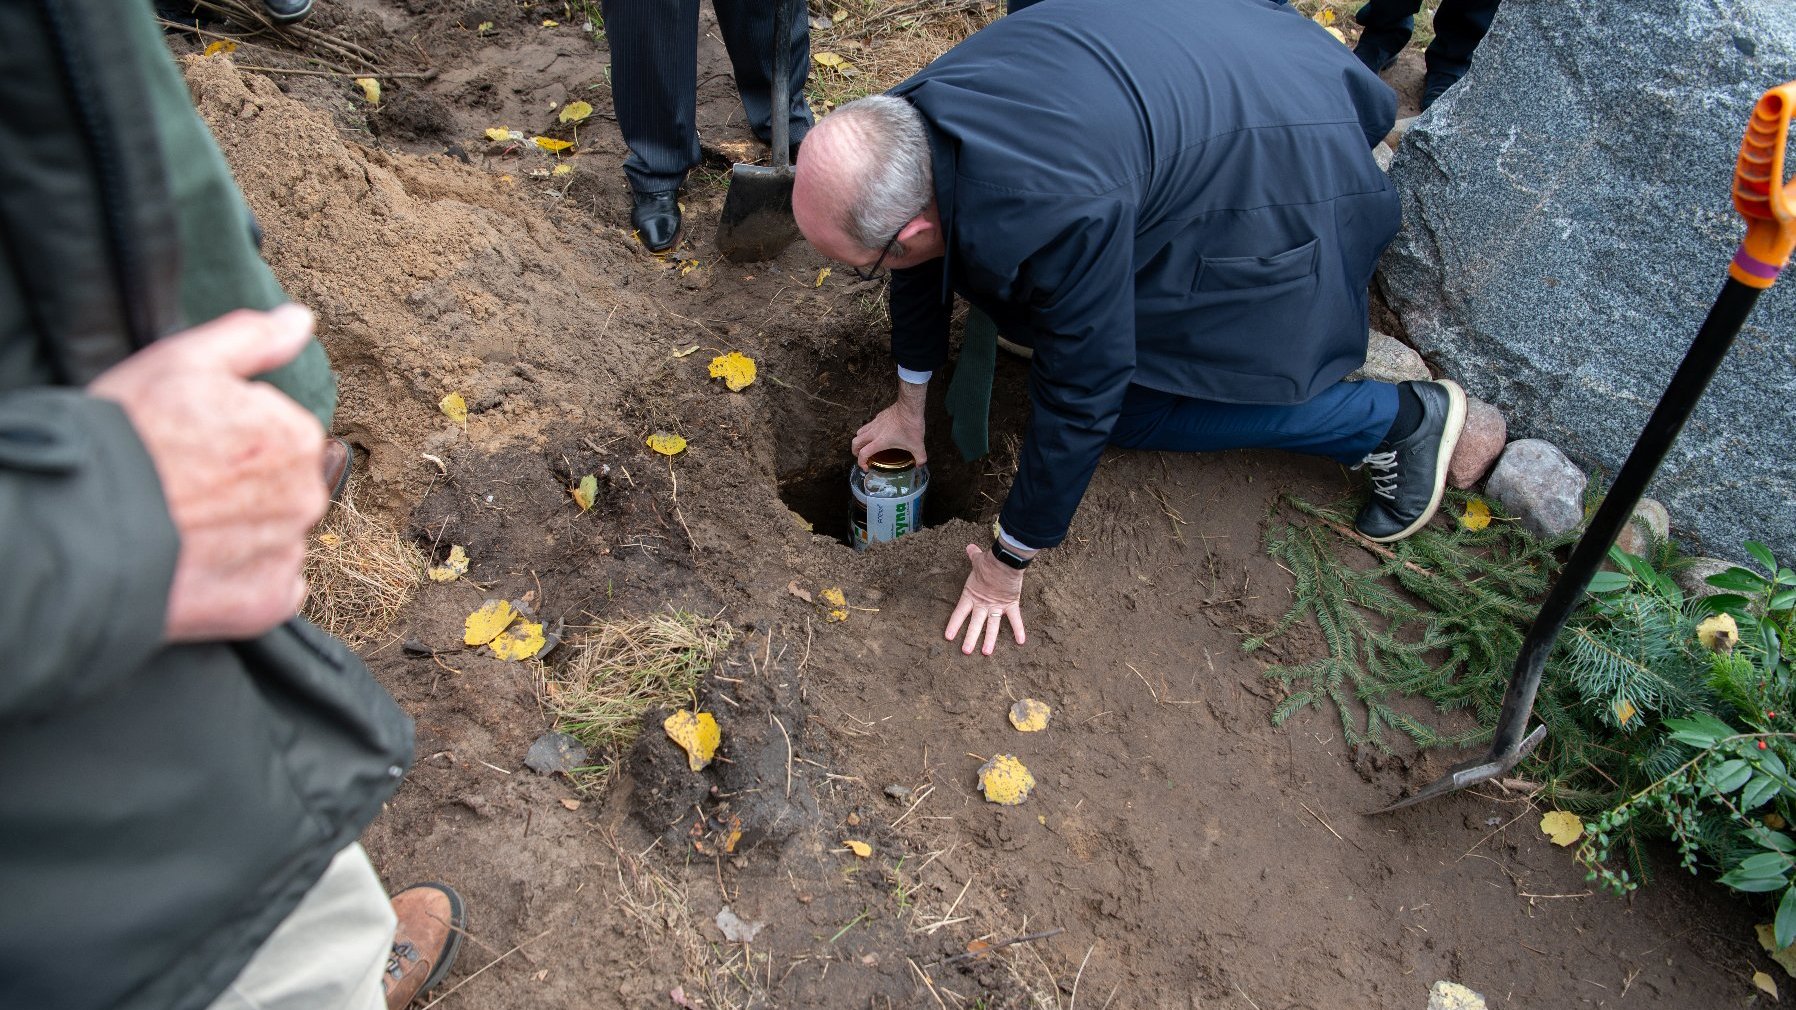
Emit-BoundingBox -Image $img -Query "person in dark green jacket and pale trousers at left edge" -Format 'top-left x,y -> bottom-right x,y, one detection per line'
0,0 -> 460,1010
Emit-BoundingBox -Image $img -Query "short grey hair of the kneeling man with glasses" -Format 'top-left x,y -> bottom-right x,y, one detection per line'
830,95 -> 936,250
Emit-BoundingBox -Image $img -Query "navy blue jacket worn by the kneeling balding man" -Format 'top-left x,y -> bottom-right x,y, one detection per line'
891,0 -> 1399,548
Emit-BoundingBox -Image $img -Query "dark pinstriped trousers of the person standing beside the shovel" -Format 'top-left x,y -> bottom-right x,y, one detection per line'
603,0 -> 810,192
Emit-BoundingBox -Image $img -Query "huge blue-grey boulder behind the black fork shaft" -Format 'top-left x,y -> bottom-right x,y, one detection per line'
1379,0 -> 1796,555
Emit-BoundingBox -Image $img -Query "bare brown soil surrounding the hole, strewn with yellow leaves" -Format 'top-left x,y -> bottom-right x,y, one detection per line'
174,0 -> 1764,1010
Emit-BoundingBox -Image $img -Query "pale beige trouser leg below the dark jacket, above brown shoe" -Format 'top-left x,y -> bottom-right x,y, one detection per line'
210,843 -> 397,1010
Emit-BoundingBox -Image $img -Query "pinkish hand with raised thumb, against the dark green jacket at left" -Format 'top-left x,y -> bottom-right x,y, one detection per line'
88,306 -> 329,642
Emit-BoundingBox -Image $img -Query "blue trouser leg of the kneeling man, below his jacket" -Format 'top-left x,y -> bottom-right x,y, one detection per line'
1110,381 -> 1397,465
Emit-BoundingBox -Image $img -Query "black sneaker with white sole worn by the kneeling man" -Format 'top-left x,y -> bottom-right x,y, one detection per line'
1352,379 -> 1466,543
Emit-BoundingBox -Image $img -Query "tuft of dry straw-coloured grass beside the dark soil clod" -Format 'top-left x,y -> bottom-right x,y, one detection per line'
537,611 -> 735,751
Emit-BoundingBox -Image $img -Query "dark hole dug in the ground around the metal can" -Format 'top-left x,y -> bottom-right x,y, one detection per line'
776,332 -> 1029,545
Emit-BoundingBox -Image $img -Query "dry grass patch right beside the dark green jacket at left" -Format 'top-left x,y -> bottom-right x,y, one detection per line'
304,485 -> 424,645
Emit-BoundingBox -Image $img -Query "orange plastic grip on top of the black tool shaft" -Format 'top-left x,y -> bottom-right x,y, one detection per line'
1728,81 -> 1796,288
